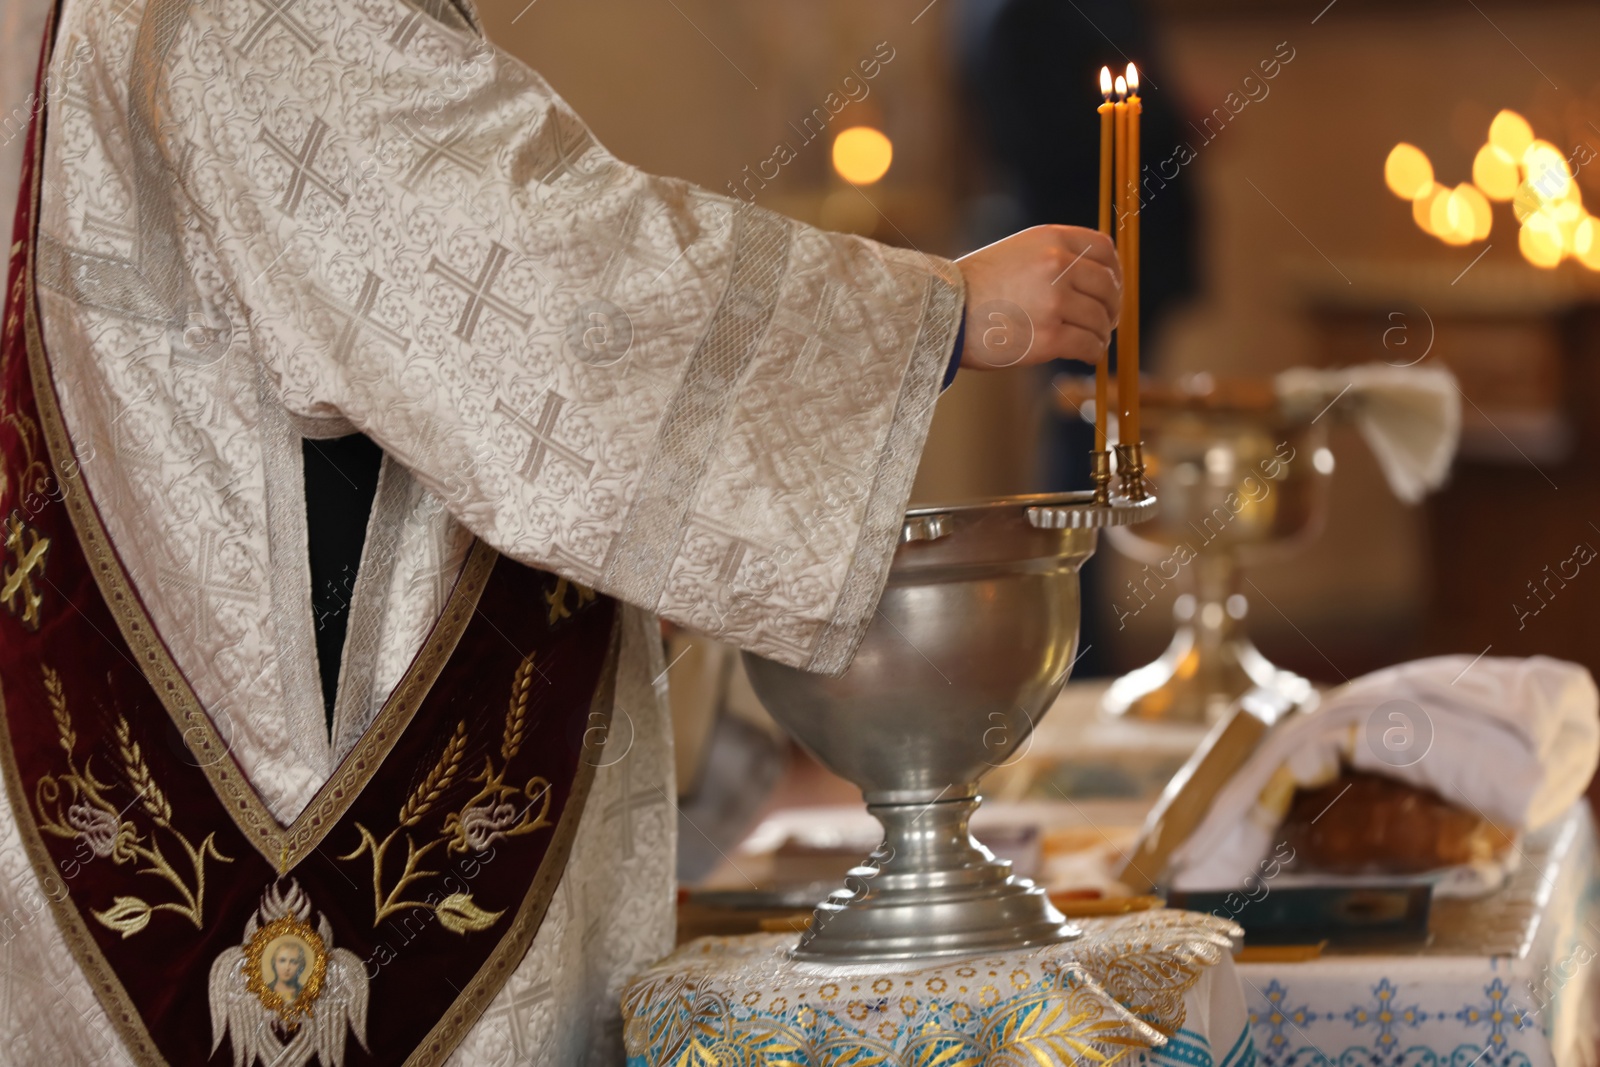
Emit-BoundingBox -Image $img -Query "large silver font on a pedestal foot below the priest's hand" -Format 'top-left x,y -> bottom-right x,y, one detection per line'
744,493 -> 1157,961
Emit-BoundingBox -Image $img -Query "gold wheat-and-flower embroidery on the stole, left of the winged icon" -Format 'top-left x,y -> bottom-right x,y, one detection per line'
34,664 -> 234,937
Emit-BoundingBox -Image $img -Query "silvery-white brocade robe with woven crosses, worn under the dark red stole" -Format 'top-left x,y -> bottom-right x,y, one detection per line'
0,0 -> 963,1065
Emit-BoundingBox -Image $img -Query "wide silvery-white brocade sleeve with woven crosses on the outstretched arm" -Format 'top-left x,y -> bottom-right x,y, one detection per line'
157,0 -> 963,673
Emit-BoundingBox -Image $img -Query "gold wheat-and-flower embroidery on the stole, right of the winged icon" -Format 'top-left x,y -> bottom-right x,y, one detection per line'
339,656 -> 552,934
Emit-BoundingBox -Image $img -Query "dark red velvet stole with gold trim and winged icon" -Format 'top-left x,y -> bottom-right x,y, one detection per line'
0,27 -> 618,1067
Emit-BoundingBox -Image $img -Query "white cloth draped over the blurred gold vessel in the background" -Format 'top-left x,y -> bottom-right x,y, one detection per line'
1275,363 -> 1461,504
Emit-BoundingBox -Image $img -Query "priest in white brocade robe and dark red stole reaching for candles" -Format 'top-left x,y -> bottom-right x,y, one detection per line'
0,0 -> 1118,1067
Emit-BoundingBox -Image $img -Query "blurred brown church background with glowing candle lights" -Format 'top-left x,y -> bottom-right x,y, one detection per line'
483,0 -> 1600,880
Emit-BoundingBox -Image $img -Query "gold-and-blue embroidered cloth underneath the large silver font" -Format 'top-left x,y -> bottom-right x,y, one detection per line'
622,910 -> 1256,1067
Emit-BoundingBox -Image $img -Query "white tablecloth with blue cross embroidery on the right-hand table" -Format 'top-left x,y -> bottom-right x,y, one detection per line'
1238,800 -> 1600,1067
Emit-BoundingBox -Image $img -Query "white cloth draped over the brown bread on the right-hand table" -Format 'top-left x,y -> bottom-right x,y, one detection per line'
1171,656 -> 1600,889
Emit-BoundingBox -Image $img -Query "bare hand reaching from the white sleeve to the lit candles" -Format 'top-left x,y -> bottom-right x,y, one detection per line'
955,226 -> 1122,370
